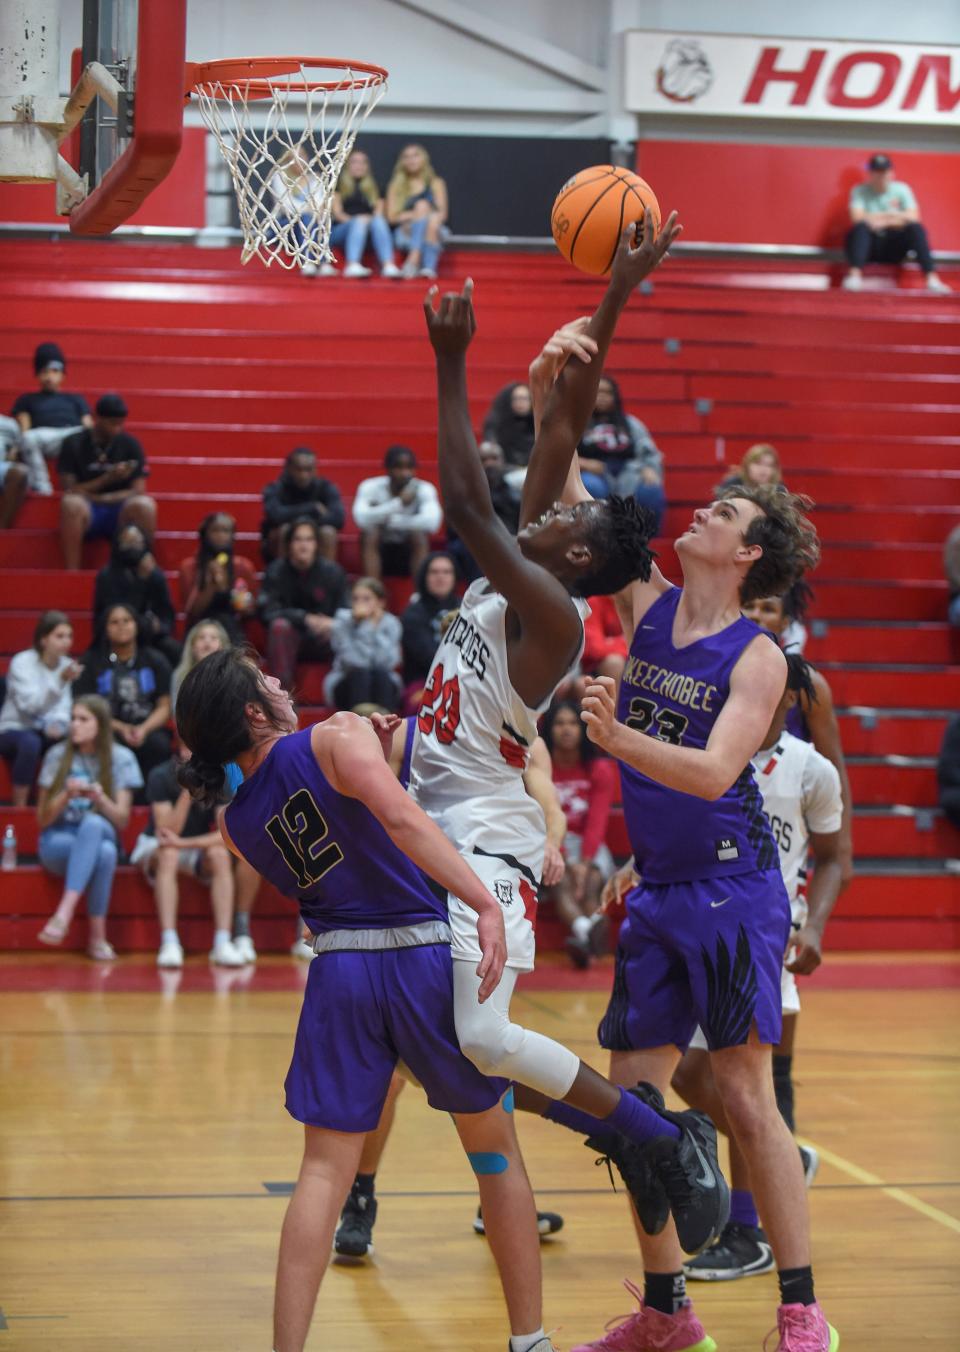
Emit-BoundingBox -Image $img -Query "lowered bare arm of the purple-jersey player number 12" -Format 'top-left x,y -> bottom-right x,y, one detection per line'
311,714 -> 507,1000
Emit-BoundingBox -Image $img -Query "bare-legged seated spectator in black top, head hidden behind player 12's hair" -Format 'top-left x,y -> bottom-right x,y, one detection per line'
130,746 -> 245,967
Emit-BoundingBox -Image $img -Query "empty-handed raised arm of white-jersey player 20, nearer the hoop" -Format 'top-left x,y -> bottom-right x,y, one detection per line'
423,281 -> 583,706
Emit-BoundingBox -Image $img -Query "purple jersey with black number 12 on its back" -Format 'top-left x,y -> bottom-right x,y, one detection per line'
226,727 -> 446,934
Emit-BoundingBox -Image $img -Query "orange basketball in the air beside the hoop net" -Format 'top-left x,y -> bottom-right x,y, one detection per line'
550,165 -> 660,277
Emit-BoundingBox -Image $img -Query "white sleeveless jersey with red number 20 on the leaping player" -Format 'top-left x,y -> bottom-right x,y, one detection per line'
410,577 -> 590,879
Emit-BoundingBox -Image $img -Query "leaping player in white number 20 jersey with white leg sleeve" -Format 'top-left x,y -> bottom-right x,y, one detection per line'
411,237 -> 727,1281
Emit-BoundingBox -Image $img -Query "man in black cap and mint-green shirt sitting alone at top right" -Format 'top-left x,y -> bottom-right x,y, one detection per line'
842,154 -> 951,295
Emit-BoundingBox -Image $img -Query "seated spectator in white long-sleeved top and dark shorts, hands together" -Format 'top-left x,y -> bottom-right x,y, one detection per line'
353,446 -> 443,577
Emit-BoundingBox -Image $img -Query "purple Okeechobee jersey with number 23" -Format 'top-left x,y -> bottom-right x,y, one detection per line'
617,587 -> 777,883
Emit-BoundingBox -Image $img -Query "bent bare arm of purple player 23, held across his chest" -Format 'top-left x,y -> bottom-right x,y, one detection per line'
581,634 -> 787,802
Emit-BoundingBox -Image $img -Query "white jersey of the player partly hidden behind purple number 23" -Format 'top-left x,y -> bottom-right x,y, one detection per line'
753,731 -> 844,927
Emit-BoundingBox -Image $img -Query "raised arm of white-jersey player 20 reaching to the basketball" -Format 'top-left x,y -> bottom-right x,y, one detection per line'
521,210 -> 681,526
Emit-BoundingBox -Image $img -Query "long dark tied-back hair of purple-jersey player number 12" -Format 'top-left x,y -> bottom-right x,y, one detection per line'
177,648 -> 284,807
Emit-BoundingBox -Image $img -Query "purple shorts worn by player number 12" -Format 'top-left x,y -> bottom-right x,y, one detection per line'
285,944 -> 508,1132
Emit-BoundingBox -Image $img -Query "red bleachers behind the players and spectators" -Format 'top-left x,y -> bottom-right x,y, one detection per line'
0,241 -> 960,949
